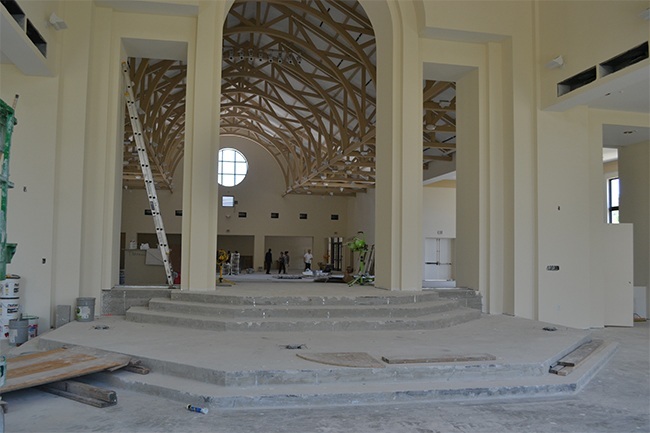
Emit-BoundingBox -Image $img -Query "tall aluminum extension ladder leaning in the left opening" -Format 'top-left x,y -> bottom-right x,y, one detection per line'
122,62 -> 174,286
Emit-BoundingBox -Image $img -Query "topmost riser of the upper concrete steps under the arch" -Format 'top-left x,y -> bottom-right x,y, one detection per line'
171,291 -> 439,306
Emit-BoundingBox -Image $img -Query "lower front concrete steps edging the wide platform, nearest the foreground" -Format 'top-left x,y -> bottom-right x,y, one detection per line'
73,343 -> 617,409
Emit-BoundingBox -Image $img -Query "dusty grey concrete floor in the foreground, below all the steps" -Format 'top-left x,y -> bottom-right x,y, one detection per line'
3,316 -> 650,433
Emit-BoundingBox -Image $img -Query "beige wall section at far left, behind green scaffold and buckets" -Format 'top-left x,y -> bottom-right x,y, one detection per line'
0,65 -> 59,329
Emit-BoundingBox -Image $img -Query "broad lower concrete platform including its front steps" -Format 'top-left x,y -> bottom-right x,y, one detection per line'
34,310 -> 616,408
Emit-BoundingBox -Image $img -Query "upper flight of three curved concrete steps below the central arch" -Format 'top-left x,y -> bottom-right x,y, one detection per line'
126,290 -> 481,332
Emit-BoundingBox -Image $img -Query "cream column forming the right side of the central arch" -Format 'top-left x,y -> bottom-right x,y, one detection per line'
363,2 -> 423,290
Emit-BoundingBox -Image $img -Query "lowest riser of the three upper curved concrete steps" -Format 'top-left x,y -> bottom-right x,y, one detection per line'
126,310 -> 480,332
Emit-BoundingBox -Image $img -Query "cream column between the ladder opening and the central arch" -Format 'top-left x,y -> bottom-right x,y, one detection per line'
181,2 -> 225,290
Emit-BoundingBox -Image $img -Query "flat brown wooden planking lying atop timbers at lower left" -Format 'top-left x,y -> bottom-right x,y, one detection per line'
0,346 -> 130,394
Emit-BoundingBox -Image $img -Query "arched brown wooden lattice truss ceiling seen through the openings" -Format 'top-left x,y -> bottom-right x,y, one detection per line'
123,0 -> 455,195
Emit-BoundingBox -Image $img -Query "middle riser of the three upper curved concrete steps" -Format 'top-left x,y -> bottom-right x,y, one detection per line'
149,299 -> 458,319
